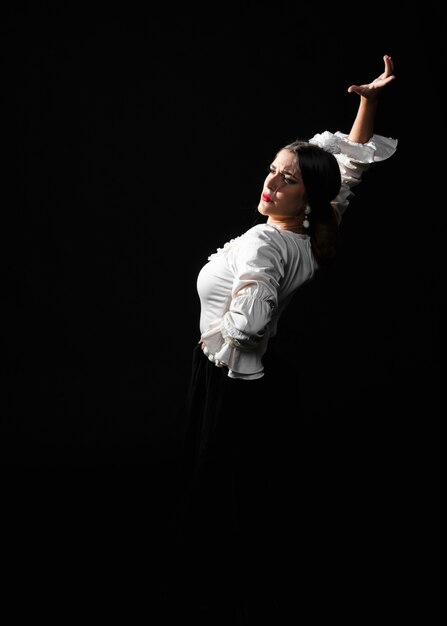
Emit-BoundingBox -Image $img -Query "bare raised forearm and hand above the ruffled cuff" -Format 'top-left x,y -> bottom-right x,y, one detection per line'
348,54 -> 395,143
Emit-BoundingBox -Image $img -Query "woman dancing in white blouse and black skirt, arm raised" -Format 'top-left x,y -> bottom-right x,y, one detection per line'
172,55 -> 397,619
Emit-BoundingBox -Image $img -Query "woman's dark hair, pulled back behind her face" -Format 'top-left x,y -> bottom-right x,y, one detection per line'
282,139 -> 341,264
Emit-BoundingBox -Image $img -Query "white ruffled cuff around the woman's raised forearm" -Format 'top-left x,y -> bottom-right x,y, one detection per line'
309,130 -> 398,163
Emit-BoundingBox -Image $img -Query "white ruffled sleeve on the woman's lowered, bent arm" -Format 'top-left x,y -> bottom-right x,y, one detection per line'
201,228 -> 285,378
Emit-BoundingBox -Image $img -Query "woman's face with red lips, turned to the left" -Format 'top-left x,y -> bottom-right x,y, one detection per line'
258,150 -> 306,227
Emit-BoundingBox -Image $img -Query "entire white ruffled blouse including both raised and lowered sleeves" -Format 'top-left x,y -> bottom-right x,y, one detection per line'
197,131 -> 397,379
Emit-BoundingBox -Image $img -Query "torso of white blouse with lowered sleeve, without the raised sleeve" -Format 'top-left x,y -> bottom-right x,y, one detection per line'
197,224 -> 316,378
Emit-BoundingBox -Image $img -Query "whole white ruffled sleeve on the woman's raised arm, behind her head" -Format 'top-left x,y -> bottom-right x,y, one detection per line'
309,131 -> 397,221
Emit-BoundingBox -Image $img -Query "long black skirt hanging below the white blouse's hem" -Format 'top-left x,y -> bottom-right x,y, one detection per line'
168,346 -> 284,624
